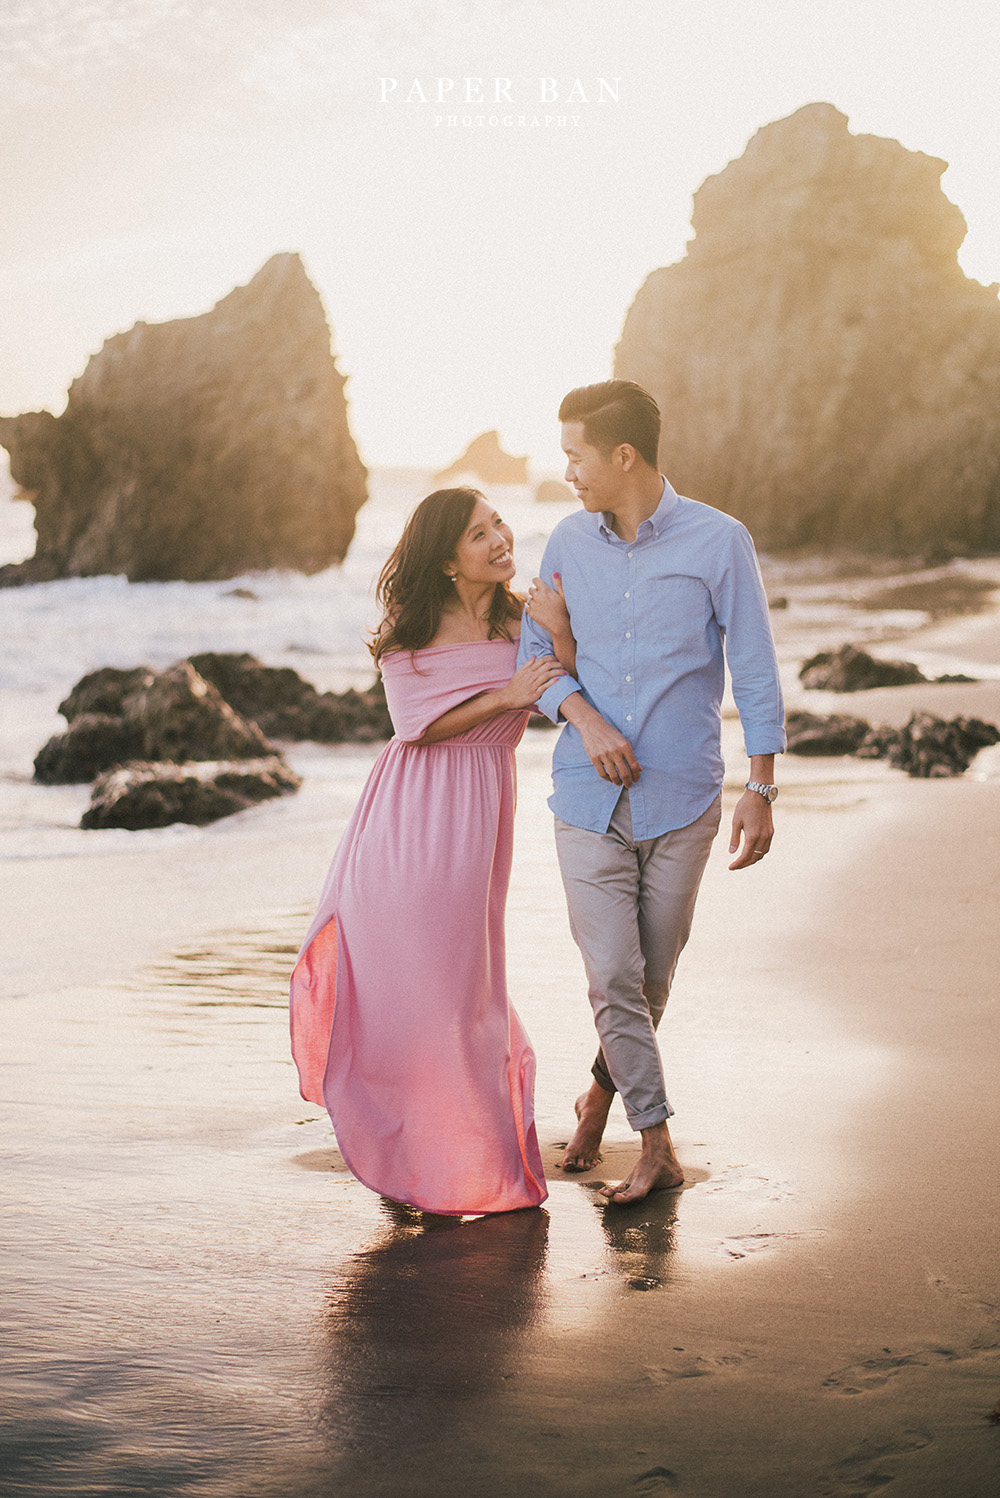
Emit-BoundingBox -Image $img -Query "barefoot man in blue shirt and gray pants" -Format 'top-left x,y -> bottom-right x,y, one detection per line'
519,380 -> 784,1203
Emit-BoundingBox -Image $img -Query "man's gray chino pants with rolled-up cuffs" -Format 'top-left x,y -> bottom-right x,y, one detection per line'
555,791 -> 722,1129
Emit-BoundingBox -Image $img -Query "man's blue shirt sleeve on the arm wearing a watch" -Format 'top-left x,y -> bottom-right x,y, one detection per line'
711,526 -> 786,756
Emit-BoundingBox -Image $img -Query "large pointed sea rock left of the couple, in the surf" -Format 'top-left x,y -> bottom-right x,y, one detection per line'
0,255 -> 367,583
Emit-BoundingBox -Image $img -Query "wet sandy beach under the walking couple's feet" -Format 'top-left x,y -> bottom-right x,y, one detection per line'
1,625 -> 1000,1498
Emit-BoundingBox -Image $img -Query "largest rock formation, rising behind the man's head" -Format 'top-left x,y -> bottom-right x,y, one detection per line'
615,103 -> 1000,554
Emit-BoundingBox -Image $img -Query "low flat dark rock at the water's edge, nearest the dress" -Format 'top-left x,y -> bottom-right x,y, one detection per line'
79,755 -> 301,830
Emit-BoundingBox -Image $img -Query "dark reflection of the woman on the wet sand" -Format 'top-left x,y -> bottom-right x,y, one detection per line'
323,1203 -> 549,1494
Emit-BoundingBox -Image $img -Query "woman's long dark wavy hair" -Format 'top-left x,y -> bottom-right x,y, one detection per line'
368,488 -> 521,665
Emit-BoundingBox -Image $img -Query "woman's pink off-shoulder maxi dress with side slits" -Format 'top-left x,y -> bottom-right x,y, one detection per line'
290,640 -> 548,1213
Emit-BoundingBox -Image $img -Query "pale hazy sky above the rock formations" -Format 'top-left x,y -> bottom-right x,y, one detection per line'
0,0 -> 1000,467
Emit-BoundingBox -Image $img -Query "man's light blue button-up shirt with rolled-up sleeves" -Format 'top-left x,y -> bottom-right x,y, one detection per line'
518,481 -> 784,840
